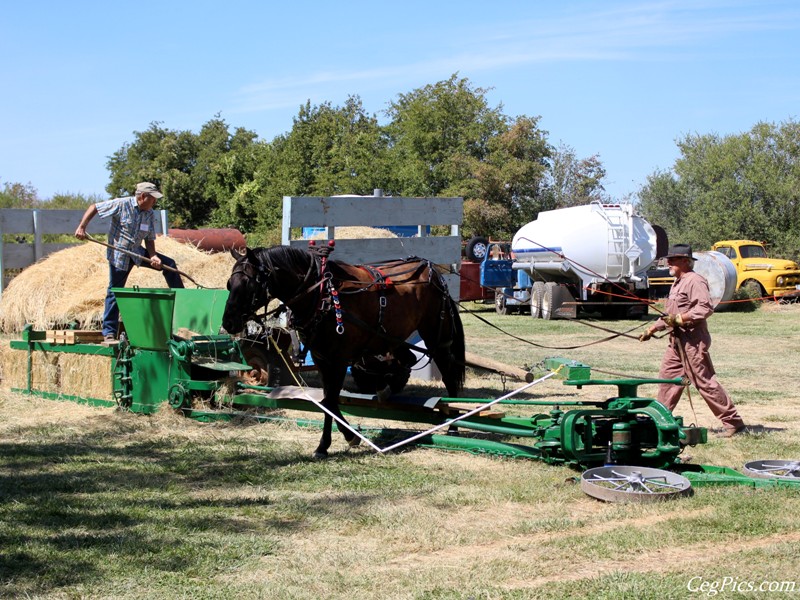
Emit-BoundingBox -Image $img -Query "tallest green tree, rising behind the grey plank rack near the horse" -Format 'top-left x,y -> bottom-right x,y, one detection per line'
386,74 -> 551,237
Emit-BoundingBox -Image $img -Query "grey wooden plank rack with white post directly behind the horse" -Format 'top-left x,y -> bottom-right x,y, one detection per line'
282,195 -> 464,300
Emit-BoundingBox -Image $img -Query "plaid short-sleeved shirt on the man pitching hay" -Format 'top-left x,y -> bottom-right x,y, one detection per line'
95,196 -> 156,270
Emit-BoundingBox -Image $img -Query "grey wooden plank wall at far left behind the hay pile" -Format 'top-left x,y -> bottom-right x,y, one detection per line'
0,208 -> 168,297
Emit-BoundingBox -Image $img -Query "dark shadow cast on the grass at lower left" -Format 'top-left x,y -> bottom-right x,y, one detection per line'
0,431 -> 376,597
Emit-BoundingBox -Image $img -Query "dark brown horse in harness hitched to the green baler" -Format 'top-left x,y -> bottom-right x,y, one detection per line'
222,246 -> 465,458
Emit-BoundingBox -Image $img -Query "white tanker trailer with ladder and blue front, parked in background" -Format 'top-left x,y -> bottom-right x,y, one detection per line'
481,202 -> 667,319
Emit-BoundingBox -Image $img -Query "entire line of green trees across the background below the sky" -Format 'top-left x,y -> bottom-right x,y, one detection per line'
0,74 -> 800,256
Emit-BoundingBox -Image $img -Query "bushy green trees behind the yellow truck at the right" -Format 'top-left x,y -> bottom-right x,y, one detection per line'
639,120 -> 800,256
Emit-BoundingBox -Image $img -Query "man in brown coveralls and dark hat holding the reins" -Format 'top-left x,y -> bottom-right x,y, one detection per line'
639,244 -> 745,437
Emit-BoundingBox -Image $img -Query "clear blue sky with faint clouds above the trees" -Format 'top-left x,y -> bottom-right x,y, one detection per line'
0,0 -> 800,198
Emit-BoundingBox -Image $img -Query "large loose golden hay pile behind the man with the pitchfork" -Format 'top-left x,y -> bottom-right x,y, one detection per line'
0,236 -> 234,333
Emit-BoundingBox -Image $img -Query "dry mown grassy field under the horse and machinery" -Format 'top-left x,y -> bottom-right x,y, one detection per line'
0,305 -> 800,600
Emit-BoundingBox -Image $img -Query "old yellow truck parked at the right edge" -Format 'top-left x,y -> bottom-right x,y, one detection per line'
712,240 -> 800,297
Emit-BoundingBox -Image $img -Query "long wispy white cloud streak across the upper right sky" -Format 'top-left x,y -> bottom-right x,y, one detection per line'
232,0 -> 800,112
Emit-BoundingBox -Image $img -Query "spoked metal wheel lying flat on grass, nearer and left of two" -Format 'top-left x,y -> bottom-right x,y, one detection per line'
581,466 -> 692,502
